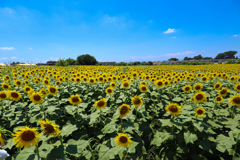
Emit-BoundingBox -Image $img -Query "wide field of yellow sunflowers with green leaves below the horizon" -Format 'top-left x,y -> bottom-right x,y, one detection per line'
0,64 -> 240,160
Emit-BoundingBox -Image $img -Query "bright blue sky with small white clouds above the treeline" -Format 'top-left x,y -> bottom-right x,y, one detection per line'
0,0 -> 240,63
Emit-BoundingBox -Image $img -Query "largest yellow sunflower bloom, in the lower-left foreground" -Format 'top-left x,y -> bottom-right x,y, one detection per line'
12,126 -> 40,148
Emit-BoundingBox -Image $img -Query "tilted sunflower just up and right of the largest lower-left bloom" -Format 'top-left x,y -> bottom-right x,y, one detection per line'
38,118 -> 61,136
